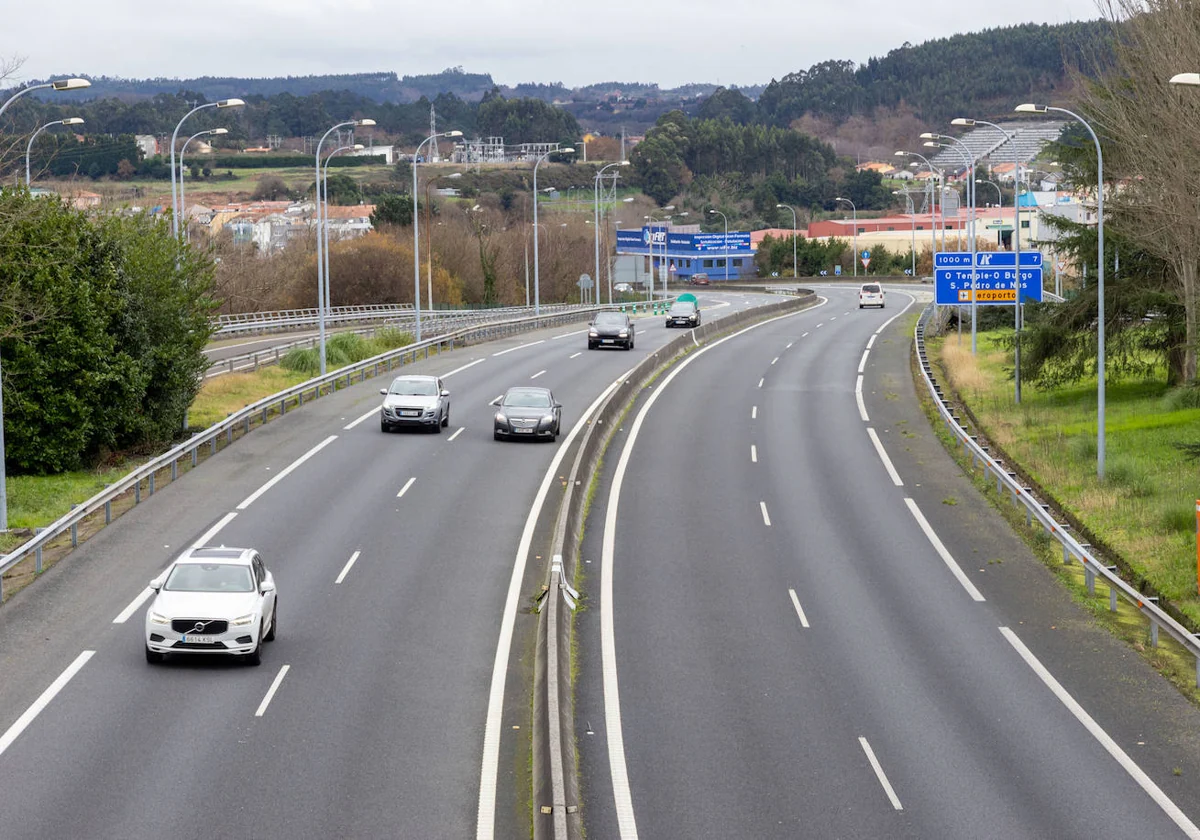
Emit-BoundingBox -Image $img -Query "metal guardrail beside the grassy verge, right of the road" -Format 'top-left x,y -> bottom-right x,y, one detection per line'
913,304 -> 1200,688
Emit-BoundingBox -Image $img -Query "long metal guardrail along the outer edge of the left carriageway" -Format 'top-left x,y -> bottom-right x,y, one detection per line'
0,306 -> 607,604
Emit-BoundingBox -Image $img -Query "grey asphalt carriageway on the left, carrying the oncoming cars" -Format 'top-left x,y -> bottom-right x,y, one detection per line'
0,293 -> 778,840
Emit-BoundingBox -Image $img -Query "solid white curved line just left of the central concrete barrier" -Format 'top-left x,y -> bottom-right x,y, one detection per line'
475,368 -> 633,840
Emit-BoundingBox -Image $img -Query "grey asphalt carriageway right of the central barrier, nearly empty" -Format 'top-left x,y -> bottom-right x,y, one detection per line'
575,288 -> 1200,840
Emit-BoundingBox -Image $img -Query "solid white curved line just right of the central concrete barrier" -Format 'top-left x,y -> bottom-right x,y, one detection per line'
600,312 -> 798,840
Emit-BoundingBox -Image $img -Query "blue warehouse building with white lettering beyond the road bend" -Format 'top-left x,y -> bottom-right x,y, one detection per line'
617,224 -> 755,282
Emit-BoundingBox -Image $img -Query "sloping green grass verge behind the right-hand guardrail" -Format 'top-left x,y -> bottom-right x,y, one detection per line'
937,332 -> 1200,625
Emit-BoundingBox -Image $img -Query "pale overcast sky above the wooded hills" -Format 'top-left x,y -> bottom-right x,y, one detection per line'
7,0 -> 1099,88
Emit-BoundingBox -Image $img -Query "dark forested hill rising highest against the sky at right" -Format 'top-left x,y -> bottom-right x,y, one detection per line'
758,20 -> 1111,126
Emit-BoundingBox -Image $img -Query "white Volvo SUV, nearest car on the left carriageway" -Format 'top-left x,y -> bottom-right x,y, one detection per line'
145,547 -> 278,665
